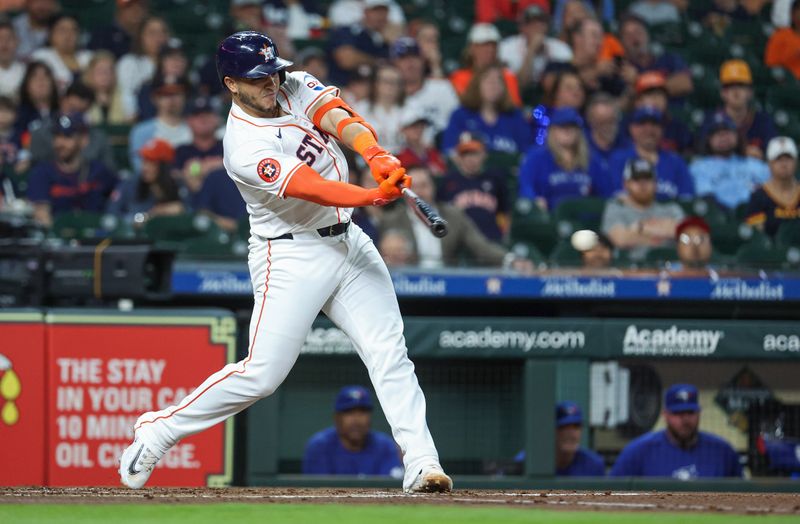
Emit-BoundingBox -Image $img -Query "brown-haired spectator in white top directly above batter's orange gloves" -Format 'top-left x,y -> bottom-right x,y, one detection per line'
353,64 -> 403,153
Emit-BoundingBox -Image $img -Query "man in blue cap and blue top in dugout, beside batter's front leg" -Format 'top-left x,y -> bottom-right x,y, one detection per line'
303,386 -> 403,478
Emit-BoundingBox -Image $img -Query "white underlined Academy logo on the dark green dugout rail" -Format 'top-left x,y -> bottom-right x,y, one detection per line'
622,324 -> 725,357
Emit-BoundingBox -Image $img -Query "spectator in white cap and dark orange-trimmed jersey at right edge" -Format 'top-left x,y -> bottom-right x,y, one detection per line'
746,136 -> 800,236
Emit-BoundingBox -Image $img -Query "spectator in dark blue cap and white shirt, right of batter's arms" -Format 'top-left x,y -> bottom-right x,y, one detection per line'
391,37 -> 458,138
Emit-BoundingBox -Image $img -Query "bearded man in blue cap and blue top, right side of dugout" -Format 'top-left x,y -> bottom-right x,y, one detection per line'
610,384 -> 742,480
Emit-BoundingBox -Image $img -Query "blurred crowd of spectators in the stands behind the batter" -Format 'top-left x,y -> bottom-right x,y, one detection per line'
0,0 -> 800,272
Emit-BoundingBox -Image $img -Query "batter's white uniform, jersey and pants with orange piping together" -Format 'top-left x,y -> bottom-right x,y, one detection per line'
135,72 -> 439,487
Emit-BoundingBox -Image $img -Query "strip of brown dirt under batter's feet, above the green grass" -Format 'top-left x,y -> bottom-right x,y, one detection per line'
0,487 -> 800,515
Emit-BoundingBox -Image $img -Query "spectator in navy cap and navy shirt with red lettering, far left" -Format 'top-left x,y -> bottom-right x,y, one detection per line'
28,115 -> 117,227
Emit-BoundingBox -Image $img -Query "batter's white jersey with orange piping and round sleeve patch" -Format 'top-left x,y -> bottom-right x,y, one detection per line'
222,71 -> 353,238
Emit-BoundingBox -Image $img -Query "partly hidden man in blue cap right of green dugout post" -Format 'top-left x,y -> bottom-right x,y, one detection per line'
514,400 -> 606,477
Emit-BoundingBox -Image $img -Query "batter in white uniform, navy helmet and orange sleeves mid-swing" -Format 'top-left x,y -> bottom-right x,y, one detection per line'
119,31 -> 452,492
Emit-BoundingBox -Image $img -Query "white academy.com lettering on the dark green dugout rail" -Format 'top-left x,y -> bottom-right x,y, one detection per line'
439,326 -> 586,352
